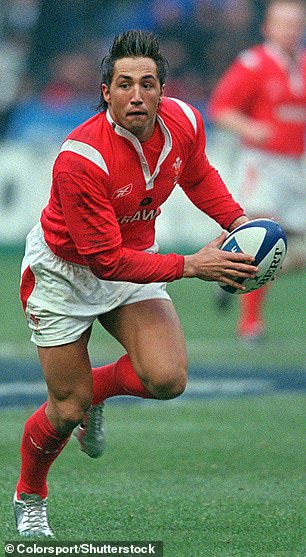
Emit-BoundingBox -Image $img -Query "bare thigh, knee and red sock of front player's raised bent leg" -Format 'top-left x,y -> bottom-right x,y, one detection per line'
93,299 -> 187,402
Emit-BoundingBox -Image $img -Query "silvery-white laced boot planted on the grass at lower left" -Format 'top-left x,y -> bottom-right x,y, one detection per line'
13,493 -> 54,537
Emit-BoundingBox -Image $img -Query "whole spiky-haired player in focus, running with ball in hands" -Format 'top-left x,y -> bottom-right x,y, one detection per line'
14,31 -> 257,536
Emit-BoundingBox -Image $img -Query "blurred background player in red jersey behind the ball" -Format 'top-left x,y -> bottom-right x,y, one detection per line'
209,0 -> 306,339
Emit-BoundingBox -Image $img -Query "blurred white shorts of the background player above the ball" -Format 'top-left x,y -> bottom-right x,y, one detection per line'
237,148 -> 306,234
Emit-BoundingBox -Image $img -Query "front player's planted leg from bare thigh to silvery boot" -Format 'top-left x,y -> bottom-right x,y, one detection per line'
14,332 -> 92,536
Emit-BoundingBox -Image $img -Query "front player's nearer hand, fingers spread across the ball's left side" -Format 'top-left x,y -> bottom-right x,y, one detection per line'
183,232 -> 258,291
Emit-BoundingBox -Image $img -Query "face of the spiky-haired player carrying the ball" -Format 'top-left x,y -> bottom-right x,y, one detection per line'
102,58 -> 163,141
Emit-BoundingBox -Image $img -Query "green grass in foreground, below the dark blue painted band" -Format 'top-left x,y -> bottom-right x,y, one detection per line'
0,394 -> 306,557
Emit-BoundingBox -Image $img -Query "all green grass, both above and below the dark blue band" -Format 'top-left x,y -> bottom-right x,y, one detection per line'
0,254 -> 306,557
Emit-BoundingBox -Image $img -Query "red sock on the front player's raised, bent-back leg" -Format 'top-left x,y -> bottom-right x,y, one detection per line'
92,354 -> 155,405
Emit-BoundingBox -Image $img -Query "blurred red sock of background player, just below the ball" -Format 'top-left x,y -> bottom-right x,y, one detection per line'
238,286 -> 267,336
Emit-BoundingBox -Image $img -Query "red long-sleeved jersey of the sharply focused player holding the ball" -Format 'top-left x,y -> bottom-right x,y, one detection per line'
41,98 -> 243,283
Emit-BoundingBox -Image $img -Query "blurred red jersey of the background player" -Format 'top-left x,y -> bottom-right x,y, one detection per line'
209,43 -> 306,157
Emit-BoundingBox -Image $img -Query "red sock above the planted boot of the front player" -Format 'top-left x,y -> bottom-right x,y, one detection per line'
16,403 -> 70,498
